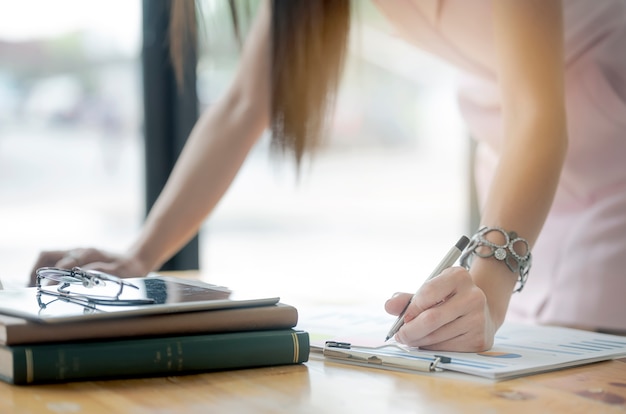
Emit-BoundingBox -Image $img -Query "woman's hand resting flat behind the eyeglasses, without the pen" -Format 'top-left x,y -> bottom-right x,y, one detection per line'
30,248 -> 150,286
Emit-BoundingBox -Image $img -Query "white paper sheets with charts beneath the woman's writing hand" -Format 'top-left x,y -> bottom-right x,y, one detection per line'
299,306 -> 626,380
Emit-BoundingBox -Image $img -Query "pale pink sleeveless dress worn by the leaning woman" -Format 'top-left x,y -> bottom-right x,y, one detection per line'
375,0 -> 626,331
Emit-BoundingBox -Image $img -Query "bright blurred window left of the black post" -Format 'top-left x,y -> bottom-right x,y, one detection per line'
0,0 -> 144,285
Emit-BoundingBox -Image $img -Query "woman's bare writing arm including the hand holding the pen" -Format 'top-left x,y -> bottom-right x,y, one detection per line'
386,0 -> 567,351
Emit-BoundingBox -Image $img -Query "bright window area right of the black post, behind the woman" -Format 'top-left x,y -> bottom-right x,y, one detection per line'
198,1 -> 469,305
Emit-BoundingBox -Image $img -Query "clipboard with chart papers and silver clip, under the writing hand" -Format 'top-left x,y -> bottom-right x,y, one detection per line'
322,323 -> 626,381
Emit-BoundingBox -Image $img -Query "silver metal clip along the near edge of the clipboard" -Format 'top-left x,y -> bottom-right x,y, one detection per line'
323,341 -> 452,372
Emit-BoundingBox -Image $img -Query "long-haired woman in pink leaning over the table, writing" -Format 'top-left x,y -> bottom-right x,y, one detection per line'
37,0 -> 626,351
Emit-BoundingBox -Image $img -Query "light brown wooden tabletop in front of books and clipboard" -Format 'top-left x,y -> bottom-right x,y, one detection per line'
0,274 -> 626,414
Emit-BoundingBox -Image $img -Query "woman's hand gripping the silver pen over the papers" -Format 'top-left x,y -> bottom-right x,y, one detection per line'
385,267 -> 498,352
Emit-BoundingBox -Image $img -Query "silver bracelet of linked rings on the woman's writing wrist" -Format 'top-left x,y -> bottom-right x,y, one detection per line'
459,227 -> 532,292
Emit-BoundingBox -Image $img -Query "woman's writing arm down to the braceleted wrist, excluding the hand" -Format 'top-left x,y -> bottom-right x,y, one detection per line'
470,0 -> 567,326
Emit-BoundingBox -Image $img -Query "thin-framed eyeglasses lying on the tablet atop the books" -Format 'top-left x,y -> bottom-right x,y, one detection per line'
36,267 -> 155,309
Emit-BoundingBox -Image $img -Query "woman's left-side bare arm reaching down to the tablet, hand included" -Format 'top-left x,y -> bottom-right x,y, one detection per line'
31,2 -> 271,283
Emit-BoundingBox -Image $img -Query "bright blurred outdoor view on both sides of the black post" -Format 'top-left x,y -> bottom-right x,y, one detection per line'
0,0 -> 469,306
